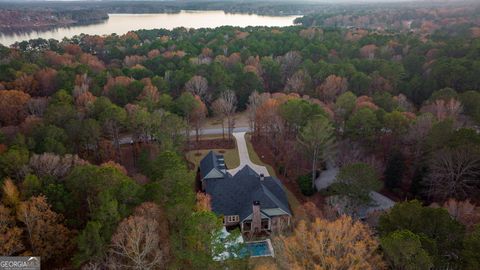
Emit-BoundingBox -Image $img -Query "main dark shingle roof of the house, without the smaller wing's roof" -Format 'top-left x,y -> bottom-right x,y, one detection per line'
205,166 -> 291,220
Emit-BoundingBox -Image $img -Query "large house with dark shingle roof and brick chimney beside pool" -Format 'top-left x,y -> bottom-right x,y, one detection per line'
198,151 -> 292,234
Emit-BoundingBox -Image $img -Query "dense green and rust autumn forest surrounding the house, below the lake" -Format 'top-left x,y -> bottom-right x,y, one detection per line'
0,4 -> 480,269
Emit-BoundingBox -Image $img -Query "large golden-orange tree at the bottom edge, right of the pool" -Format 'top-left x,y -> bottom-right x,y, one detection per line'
274,216 -> 386,270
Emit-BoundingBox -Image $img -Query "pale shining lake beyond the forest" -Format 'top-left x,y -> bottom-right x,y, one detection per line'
0,10 -> 299,46
